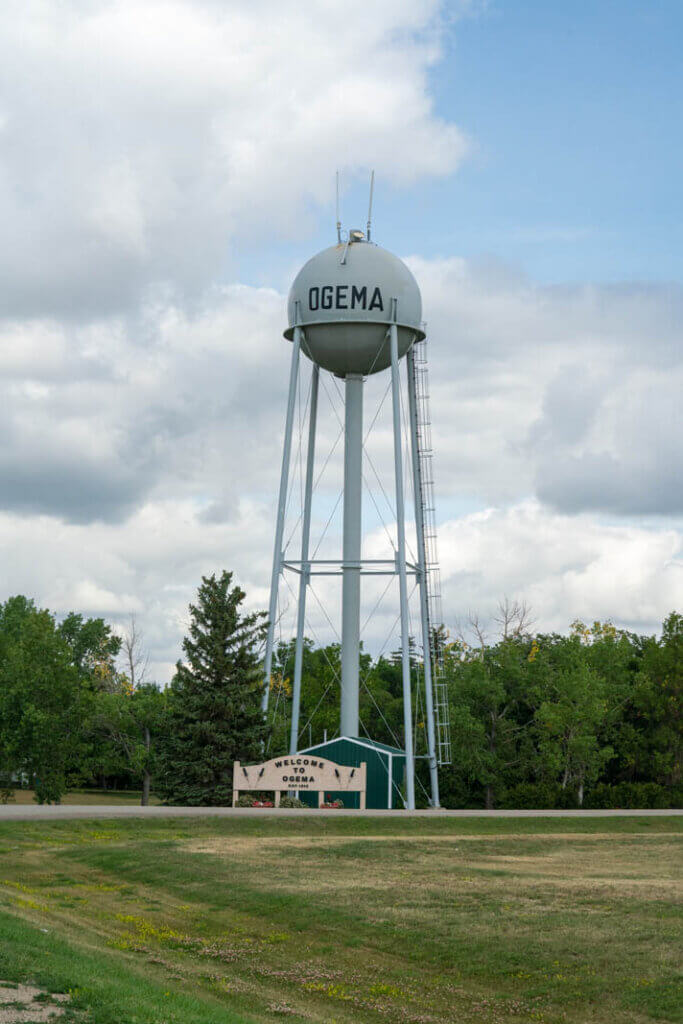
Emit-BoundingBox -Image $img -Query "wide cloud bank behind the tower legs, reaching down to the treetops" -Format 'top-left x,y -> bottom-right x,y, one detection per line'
0,259 -> 683,680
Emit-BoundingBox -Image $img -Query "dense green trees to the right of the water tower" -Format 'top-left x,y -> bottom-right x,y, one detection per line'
432,614 -> 683,808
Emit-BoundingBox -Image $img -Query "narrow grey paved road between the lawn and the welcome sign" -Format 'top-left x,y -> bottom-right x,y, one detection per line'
0,804 -> 683,821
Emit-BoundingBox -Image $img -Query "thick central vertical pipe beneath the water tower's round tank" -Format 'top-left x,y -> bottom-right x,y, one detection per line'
341,374 -> 362,736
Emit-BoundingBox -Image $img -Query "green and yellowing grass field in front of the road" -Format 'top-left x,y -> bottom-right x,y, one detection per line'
0,813 -> 683,1024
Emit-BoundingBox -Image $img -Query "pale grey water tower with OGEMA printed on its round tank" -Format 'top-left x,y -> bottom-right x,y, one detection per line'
263,193 -> 450,809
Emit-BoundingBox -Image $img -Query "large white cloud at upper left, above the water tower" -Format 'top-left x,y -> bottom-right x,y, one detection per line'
0,0 -> 467,318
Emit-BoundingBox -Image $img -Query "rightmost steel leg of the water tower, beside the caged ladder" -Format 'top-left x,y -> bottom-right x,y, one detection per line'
407,348 -> 439,807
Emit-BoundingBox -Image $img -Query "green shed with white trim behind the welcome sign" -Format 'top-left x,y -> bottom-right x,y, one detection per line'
297,736 -> 405,810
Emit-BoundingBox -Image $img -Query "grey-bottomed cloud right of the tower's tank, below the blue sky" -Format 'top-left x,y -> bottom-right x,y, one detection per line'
411,258 -> 683,516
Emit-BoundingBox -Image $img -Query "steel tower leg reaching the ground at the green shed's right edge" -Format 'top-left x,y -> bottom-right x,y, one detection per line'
389,324 -> 415,811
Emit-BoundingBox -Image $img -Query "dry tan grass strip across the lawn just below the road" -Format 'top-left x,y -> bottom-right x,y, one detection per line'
187,833 -> 683,902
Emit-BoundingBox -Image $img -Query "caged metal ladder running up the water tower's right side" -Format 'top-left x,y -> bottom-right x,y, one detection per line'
414,338 -> 453,765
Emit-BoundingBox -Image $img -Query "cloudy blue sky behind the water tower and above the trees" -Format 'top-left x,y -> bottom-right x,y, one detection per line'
0,0 -> 683,683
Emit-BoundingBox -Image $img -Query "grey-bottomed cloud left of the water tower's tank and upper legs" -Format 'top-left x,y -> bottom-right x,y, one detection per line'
0,286 -> 288,522
